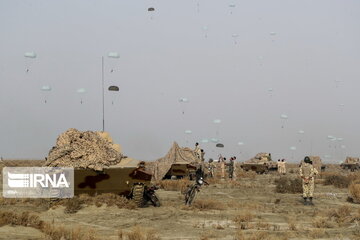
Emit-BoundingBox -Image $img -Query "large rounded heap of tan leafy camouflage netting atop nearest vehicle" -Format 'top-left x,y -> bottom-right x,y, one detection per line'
44,128 -> 123,171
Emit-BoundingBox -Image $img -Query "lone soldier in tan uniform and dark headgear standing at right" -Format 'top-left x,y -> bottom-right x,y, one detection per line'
300,156 -> 318,205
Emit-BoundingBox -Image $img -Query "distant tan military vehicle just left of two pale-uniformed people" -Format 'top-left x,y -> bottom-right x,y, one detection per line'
240,153 -> 277,174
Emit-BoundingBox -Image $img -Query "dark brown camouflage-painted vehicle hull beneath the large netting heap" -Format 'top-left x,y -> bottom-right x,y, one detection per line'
74,158 -> 160,207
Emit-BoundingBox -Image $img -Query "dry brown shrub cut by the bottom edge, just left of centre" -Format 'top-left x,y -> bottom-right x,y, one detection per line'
118,226 -> 160,240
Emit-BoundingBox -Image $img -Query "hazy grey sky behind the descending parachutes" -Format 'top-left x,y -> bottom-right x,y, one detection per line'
0,0 -> 360,162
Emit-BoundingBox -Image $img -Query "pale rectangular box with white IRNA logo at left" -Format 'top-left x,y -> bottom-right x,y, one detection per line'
2,167 -> 74,198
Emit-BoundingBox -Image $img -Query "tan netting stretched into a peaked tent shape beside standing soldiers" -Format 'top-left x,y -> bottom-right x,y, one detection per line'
146,142 -> 200,181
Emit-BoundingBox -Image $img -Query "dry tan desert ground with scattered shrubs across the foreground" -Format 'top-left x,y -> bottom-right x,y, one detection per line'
0,160 -> 360,240
